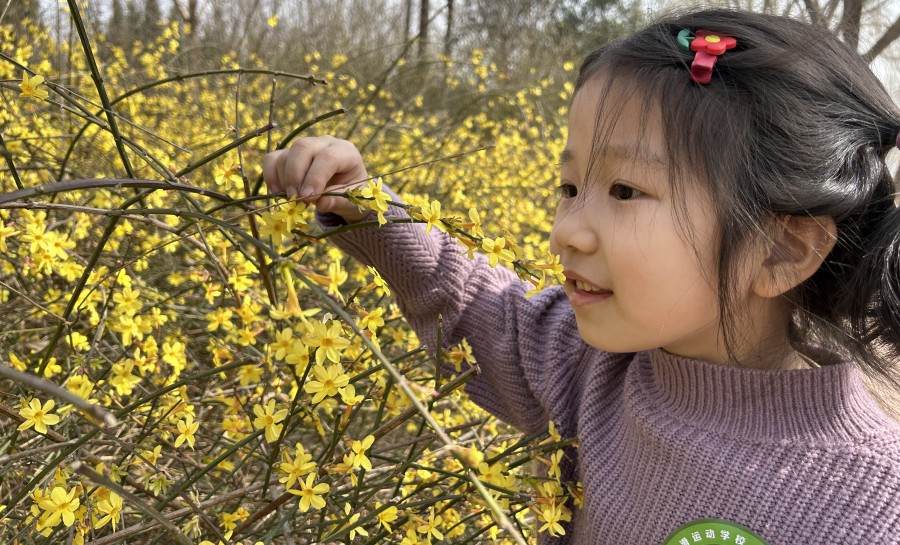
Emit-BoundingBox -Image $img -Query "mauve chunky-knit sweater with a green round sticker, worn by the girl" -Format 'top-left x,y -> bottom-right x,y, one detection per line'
319,199 -> 900,545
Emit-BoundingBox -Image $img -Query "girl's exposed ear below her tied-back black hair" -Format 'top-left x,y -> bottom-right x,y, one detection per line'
752,216 -> 837,297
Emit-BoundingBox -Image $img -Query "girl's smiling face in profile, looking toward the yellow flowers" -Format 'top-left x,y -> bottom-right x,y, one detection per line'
550,81 -> 741,362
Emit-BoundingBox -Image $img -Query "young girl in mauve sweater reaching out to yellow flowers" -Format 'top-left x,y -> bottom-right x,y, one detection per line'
264,11 -> 900,545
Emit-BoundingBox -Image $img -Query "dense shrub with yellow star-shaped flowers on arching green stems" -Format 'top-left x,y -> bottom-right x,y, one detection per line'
0,2 -> 580,545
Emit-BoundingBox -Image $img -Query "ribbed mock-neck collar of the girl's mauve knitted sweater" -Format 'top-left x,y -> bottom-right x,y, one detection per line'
638,350 -> 900,443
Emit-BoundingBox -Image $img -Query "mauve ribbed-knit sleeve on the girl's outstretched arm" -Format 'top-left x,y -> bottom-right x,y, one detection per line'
318,196 -> 588,433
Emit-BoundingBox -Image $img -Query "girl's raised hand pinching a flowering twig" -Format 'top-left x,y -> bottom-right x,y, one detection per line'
263,136 -> 369,223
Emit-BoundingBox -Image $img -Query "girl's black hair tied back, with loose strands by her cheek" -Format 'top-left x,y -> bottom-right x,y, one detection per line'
575,9 -> 900,385
